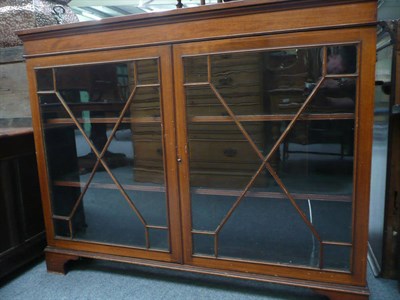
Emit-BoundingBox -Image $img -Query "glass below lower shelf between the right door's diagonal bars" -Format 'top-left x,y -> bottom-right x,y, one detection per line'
218,197 -> 319,267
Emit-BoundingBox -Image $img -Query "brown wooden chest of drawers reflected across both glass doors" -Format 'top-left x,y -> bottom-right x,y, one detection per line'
132,54 -> 264,187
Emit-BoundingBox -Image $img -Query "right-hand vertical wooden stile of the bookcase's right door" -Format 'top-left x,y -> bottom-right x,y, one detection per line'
352,28 -> 376,283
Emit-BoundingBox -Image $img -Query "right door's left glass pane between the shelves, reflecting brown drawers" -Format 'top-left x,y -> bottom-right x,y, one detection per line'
189,123 -> 265,189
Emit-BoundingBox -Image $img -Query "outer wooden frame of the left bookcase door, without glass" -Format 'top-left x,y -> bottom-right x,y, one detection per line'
27,45 -> 182,262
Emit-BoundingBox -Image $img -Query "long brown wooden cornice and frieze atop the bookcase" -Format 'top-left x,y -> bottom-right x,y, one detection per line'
19,1 -> 376,57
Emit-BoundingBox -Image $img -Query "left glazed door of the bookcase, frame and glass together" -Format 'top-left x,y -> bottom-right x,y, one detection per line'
33,47 -> 180,261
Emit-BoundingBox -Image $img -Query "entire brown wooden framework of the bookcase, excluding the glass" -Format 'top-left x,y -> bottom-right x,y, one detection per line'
19,0 -> 376,299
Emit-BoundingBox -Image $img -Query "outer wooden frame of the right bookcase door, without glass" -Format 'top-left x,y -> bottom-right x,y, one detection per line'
173,27 -> 376,286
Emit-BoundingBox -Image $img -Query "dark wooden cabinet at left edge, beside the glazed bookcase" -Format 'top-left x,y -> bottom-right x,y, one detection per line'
0,128 -> 46,278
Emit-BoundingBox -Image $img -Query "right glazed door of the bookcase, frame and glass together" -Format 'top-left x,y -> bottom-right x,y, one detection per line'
174,30 -> 373,282
